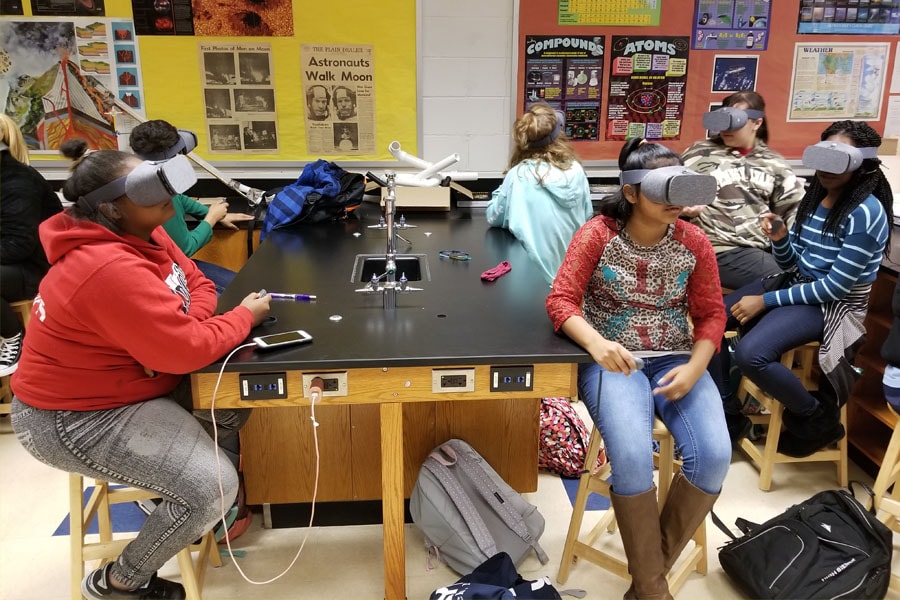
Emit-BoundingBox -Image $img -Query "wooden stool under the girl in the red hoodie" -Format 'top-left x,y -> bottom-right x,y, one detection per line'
69,473 -> 222,600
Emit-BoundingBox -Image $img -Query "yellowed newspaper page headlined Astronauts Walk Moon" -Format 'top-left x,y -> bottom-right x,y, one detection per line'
300,44 -> 375,156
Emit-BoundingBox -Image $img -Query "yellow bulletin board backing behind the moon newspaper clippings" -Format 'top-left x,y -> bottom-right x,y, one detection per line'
15,0 -> 418,162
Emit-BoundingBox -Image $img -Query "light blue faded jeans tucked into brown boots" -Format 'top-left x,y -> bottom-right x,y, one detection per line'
578,354 -> 731,496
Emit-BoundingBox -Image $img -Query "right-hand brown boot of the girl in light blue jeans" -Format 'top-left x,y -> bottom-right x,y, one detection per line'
659,471 -> 719,573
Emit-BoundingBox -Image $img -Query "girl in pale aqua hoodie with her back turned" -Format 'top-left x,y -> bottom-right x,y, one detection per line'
486,102 -> 594,284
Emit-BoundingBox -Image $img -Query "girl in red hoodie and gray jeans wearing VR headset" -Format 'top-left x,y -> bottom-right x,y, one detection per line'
12,150 -> 269,599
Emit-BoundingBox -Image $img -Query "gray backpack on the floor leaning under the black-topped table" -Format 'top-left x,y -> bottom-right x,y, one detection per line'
409,440 -> 549,575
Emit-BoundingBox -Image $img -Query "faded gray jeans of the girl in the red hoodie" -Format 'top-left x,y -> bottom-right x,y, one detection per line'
12,397 -> 250,587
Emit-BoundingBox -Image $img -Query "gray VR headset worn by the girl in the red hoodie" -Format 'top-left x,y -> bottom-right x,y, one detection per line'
82,155 -> 197,206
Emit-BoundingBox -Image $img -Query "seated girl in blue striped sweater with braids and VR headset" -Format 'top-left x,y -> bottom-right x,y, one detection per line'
725,121 -> 893,457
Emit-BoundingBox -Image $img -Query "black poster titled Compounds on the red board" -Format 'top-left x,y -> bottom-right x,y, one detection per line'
523,35 -> 604,142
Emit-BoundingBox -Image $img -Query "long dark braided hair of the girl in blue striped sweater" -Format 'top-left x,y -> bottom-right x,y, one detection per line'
794,120 -> 894,253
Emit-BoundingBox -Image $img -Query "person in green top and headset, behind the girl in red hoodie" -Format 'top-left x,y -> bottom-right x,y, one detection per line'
129,119 -> 253,294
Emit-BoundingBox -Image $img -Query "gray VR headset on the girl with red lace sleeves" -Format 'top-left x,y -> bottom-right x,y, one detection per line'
619,165 -> 718,206
